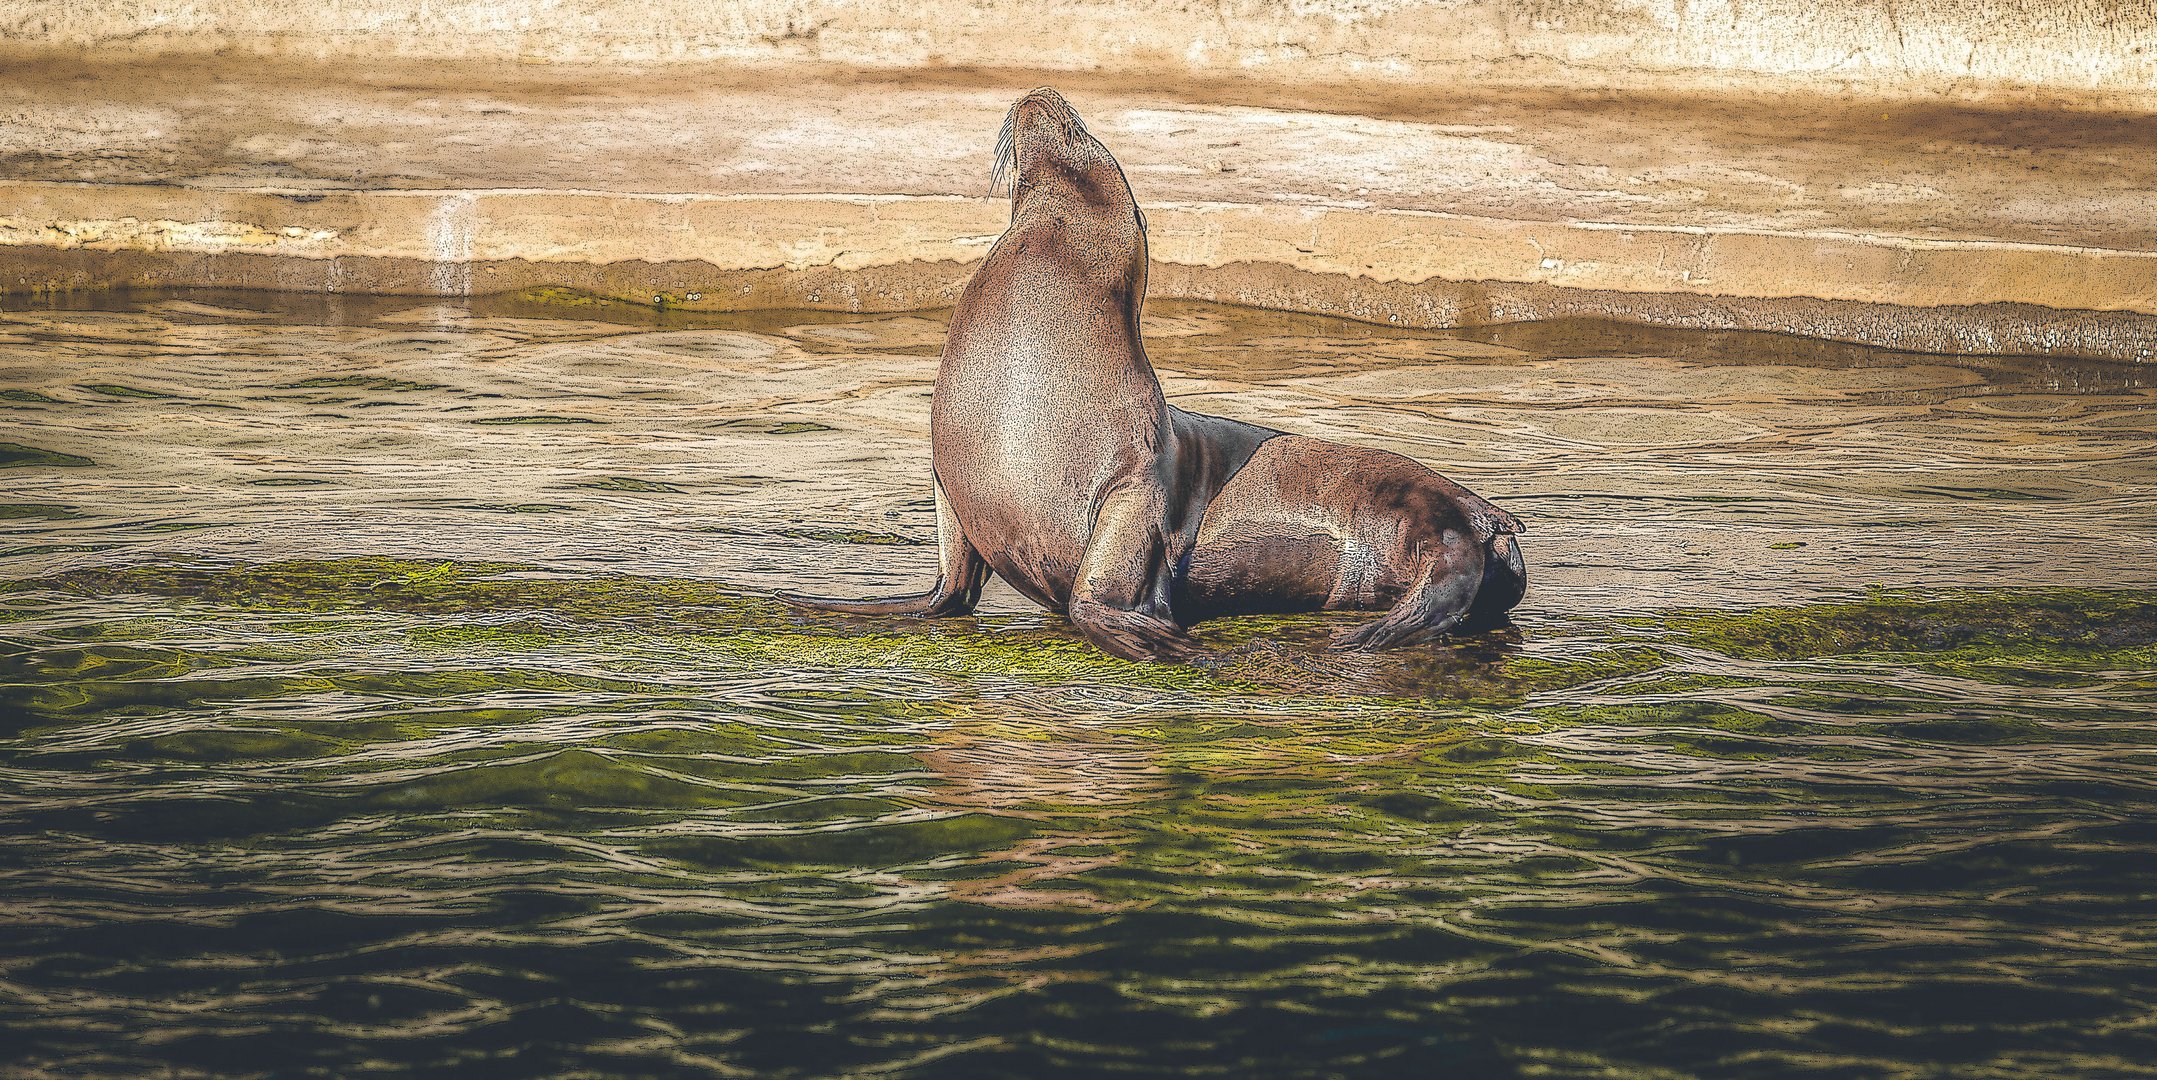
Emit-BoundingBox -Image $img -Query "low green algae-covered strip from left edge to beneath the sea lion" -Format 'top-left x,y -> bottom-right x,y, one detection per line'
9,558 -> 1663,703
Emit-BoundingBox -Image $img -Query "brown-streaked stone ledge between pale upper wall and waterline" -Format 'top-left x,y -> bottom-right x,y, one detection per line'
0,58 -> 2157,360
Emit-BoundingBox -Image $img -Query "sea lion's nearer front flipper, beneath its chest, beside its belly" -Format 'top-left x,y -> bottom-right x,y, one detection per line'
1066,487 -> 1197,660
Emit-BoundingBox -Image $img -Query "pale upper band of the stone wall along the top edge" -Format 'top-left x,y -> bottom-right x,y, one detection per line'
0,0 -> 2157,103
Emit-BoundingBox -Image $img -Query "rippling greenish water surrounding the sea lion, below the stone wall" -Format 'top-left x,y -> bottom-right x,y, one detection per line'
0,293 -> 2157,1076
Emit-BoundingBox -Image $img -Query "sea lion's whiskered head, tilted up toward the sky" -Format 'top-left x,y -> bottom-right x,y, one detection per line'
990,86 -> 1145,248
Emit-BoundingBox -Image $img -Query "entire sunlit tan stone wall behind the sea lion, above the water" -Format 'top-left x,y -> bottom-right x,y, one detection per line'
12,0 -> 2157,358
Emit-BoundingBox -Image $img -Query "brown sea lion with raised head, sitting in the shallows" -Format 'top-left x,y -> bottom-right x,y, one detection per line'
781,88 -> 1527,660
